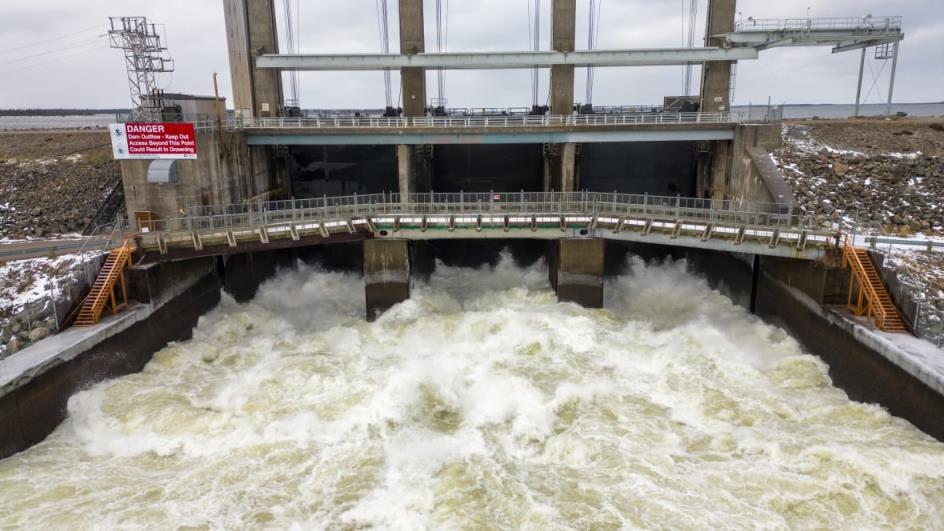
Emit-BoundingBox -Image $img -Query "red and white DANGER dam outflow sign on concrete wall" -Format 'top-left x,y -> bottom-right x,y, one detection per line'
109,122 -> 197,159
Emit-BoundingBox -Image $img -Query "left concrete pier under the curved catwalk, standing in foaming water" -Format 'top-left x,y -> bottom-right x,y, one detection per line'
364,240 -> 410,321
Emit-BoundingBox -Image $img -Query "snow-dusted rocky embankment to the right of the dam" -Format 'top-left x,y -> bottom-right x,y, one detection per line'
773,120 -> 944,236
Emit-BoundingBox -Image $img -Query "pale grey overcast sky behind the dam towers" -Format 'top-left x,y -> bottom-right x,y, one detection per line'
0,0 -> 944,108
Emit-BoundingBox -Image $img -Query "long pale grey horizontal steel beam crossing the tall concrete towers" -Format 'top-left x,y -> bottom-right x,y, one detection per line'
256,48 -> 758,70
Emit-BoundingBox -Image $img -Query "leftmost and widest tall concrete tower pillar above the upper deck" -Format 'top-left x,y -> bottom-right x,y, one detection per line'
223,0 -> 282,116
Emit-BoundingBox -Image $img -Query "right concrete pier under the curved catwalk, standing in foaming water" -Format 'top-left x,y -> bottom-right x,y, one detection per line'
557,238 -> 606,308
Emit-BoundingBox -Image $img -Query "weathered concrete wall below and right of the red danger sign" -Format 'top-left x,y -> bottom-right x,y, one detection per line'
121,132 -> 286,224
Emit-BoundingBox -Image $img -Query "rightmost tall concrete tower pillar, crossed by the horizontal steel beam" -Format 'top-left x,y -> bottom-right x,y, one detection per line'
700,0 -> 737,112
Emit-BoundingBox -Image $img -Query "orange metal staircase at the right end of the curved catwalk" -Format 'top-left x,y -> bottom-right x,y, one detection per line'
842,238 -> 908,332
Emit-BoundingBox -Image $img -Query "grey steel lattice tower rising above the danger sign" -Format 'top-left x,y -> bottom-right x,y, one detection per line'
108,17 -> 174,119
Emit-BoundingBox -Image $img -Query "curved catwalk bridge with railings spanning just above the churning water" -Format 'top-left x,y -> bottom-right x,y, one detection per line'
138,192 -> 837,261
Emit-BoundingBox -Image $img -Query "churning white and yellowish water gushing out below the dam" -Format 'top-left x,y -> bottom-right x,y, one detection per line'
0,259 -> 944,530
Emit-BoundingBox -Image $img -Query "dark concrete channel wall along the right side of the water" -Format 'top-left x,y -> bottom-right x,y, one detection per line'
683,250 -> 944,440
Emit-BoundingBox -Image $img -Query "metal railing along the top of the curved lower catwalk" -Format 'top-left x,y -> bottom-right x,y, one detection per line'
144,192 -> 813,232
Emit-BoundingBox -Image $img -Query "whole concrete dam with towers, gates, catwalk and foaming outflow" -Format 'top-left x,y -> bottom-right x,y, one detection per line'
0,0 -> 944,529
